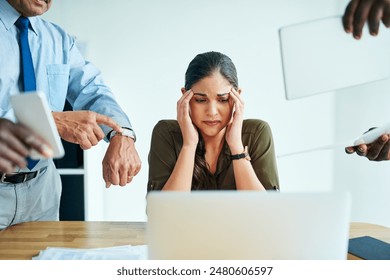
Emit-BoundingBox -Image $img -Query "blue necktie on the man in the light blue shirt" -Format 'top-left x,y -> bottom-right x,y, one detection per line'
15,16 -> 38,170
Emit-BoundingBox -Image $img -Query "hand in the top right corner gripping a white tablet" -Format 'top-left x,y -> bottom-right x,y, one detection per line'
343,0 -> 390,39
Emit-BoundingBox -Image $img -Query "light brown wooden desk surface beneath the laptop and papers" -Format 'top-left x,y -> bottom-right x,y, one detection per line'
0,222 -> 390,260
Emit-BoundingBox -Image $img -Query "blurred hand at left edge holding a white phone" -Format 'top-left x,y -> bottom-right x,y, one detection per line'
0,119 -> 53,173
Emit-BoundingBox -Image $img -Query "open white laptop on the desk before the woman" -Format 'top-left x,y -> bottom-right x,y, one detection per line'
147,191 -> 350,260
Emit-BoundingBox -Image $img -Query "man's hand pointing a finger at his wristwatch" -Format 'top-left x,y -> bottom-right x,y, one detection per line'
52,111 -> 122,150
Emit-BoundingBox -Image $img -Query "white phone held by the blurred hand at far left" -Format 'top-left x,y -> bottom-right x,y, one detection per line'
11,92 -> 65,159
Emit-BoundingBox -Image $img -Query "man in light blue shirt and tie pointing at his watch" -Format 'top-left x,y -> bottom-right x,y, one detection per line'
0,0 -> 141,229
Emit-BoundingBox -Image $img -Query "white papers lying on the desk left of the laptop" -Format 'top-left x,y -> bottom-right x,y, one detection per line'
32,245 -> 148,260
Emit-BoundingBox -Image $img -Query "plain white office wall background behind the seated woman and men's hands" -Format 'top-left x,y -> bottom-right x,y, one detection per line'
44,0 -> 390,226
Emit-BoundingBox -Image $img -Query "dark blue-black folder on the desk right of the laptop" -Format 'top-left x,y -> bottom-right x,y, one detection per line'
348,236 -> 390,260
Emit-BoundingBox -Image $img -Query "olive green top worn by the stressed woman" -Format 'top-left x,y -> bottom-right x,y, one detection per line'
148,119 -> 279,191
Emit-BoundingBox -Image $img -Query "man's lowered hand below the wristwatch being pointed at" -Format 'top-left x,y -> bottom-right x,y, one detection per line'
103,135 -> 141,188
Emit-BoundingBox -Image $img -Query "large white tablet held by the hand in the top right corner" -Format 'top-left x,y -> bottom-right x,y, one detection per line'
279,16 -> 390,100
